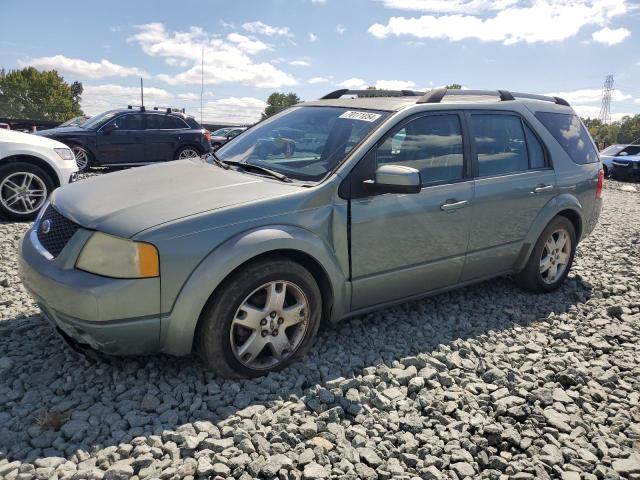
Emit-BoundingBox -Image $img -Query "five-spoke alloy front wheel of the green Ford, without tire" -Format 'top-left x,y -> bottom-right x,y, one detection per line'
229,280 -> 309,370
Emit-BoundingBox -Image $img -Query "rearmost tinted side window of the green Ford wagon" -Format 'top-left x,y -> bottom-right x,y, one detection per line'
536,112 -> 598,164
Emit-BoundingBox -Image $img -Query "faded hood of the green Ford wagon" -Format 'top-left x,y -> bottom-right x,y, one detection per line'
51,159 -> 303,237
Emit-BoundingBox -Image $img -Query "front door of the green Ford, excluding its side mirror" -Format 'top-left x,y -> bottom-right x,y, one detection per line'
350,113 -> 473,310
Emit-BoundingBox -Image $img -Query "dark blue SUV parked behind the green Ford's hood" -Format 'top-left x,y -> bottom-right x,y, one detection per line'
37,106 -> 211,171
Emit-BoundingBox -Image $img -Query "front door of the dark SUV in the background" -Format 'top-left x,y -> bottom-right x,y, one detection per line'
96,113 -> 144,165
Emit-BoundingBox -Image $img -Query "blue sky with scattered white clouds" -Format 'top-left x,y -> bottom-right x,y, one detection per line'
0,0 -> 640,123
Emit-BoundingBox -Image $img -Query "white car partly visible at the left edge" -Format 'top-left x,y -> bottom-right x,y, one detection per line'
0,129 -> 78,221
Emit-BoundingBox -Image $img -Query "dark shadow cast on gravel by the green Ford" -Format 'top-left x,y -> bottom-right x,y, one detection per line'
0,276 -> 592,461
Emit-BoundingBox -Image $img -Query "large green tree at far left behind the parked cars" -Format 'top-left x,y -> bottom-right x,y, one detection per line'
0,67 -> 83,122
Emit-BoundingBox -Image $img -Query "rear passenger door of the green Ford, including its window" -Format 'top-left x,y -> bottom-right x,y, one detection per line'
462,112 -> 556,281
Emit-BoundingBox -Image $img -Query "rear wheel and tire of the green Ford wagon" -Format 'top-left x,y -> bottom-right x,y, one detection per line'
514,216 -> 577,293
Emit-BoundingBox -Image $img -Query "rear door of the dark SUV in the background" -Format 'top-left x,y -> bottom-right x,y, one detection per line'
144,113 -> 188,162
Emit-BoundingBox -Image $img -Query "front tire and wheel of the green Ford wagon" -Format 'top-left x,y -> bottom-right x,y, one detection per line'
194,257 -> 322,378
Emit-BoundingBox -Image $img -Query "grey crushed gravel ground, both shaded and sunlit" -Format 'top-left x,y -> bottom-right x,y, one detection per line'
0,178 -> 640,480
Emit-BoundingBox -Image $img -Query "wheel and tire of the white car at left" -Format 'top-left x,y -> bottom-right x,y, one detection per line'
0,162 -> 56,221
